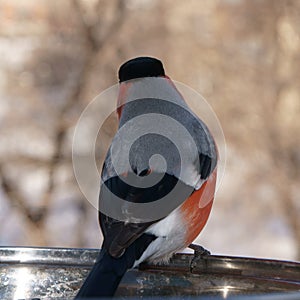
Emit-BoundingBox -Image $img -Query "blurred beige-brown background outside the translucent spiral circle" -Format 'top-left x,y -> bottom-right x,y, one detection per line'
0,0 -> 300,260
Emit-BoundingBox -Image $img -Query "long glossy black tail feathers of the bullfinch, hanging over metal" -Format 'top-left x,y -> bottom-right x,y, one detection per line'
75,234 -> 155,299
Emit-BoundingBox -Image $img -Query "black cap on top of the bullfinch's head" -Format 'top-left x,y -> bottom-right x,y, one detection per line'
119,57 -> 165,82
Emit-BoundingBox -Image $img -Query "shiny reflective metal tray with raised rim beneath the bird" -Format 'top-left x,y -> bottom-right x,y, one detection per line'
0,247 -> 300,299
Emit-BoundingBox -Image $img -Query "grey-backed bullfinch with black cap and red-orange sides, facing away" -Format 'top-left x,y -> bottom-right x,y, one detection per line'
76,57 -> 218,298
